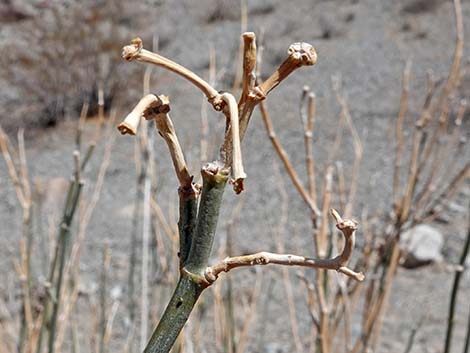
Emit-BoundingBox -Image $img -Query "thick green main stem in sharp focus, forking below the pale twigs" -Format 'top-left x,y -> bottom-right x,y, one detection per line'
144,163 -> 228,353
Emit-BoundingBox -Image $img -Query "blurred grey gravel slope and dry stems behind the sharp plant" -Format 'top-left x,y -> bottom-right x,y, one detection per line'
0,0 -> 470,353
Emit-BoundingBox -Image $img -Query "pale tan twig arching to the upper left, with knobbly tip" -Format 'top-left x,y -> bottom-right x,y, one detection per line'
122,38 -> 222,111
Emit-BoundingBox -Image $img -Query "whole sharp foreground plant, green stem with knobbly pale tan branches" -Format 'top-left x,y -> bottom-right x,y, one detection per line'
118,32 -> 364,353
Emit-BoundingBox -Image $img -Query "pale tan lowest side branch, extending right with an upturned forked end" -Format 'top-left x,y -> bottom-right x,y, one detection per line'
205,209 -> 364,283
